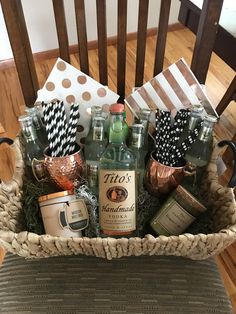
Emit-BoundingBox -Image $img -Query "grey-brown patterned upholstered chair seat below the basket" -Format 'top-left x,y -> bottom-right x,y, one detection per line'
0,254 -> 232,314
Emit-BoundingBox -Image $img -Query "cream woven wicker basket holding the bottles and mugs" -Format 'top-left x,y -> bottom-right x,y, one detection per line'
0,139 -> 236,260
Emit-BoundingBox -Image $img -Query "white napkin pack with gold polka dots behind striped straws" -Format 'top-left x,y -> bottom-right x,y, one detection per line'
38,58 -> 118,146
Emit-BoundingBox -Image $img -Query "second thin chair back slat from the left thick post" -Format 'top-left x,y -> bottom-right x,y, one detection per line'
74,0 -> 89,75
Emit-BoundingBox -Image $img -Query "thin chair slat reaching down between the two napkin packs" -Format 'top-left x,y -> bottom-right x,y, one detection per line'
117,0 -> 127,100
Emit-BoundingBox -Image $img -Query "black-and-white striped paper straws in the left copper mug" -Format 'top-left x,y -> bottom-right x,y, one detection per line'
42,101 -> 79,157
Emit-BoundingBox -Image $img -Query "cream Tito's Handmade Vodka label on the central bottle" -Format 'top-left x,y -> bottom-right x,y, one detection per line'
99,169 -> 136,235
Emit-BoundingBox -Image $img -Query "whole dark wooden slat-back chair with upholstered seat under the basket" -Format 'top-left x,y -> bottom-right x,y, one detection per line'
0,0 -> 233,313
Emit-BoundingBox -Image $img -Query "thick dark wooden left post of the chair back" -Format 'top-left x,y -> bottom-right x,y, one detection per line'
1,0 -> 39,107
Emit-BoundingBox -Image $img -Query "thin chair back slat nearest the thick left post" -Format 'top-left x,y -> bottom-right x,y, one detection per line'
52,0 -> 70,62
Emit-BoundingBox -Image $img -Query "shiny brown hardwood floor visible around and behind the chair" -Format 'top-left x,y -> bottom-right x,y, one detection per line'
0,29 -> 236,313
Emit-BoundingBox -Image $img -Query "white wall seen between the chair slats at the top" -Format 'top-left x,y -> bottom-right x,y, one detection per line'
0,0 -> 180,60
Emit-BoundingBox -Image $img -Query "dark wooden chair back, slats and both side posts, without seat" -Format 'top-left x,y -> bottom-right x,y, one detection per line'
1,0 -> 223,107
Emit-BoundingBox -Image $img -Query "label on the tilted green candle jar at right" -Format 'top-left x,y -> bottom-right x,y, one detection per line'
151,201 -> 195,235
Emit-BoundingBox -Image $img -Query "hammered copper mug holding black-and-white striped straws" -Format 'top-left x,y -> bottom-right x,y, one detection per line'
32,144 -> 85,190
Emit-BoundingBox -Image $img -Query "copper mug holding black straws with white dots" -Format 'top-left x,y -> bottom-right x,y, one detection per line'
144,153 -> 185,196
